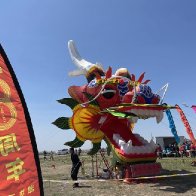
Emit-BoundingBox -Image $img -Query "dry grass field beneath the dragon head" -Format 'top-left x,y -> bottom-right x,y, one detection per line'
40,154 -> 196,196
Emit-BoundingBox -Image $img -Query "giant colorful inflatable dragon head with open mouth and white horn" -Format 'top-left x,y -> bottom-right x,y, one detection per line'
53,41 -> 175,164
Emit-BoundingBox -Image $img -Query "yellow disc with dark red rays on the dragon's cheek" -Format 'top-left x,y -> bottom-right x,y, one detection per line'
71,105 -> 104,143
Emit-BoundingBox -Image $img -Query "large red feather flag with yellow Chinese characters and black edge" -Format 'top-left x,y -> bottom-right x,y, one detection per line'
0,45 -> 44,196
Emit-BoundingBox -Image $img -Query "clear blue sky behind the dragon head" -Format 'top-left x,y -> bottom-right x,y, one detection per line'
0,0 -> 196,150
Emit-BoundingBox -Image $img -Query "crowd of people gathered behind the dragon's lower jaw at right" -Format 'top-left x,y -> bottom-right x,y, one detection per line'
157,141 -> 196,158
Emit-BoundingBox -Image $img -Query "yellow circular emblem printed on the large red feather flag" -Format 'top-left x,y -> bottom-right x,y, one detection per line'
0,80 -> 17,131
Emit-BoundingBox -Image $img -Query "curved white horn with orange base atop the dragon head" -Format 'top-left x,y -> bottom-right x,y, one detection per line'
68,40 -> 104,81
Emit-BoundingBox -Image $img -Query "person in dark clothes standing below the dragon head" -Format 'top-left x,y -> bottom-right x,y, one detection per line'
69,148 -> 82,188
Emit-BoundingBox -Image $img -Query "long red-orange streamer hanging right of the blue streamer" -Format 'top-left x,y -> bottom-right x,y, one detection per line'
176,105 -> 196,145
